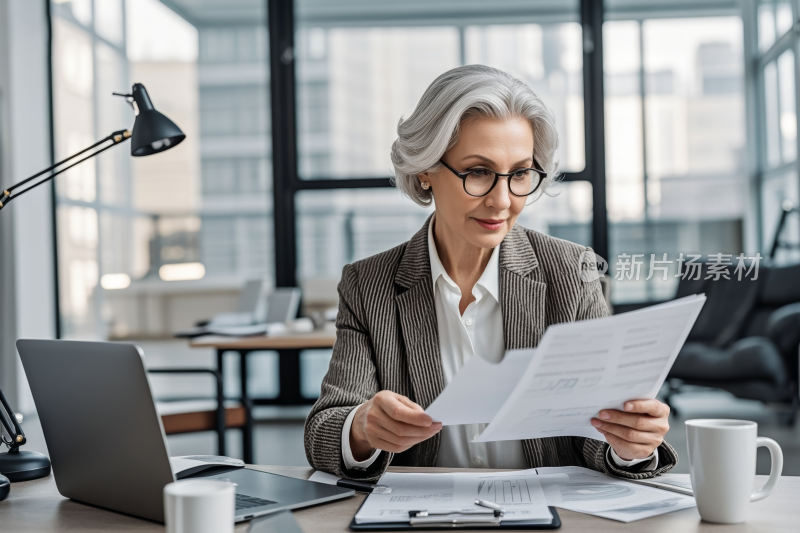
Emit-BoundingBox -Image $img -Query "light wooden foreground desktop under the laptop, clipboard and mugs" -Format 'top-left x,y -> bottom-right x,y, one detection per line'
0,466 -> 800,533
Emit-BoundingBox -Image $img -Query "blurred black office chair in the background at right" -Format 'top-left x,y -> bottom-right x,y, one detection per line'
665,265 -> 800,425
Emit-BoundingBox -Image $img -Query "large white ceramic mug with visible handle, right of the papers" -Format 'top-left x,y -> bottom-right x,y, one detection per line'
686,419 -> 783,524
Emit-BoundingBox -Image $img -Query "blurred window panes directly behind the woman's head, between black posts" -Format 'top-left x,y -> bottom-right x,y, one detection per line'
295,0 -> 592,295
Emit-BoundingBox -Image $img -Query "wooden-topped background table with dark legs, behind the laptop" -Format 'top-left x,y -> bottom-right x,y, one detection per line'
189,330 -> 336,464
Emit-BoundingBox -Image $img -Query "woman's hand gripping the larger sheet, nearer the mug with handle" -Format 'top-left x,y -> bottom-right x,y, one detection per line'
592,400 -> 669,461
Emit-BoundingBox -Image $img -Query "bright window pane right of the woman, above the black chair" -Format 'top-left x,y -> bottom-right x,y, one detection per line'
603,16 -> 757,303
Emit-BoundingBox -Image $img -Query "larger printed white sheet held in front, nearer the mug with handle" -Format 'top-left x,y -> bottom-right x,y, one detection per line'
472,295 -> 706,442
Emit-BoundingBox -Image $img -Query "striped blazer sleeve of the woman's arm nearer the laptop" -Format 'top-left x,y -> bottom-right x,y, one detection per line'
304,265 -> 393,480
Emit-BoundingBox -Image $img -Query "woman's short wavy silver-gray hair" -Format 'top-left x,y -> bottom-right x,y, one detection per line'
392,65 -> 558,207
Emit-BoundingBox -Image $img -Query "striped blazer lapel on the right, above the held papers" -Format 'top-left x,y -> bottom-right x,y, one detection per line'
500,225 -> 547,350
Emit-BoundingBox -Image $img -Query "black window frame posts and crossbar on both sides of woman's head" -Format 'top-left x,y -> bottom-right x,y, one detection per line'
265,0 -> 608,287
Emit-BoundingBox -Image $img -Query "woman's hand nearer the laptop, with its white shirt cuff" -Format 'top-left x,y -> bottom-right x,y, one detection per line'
350,390 -> 442,461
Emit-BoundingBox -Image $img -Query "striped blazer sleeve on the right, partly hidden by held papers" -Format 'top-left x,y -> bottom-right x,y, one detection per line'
574,248 -> 678,479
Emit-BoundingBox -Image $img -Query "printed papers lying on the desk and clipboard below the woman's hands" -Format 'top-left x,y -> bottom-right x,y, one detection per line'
354,466 -> 696,529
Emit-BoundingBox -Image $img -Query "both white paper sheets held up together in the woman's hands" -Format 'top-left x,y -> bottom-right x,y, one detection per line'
425,295 -> 706,442
